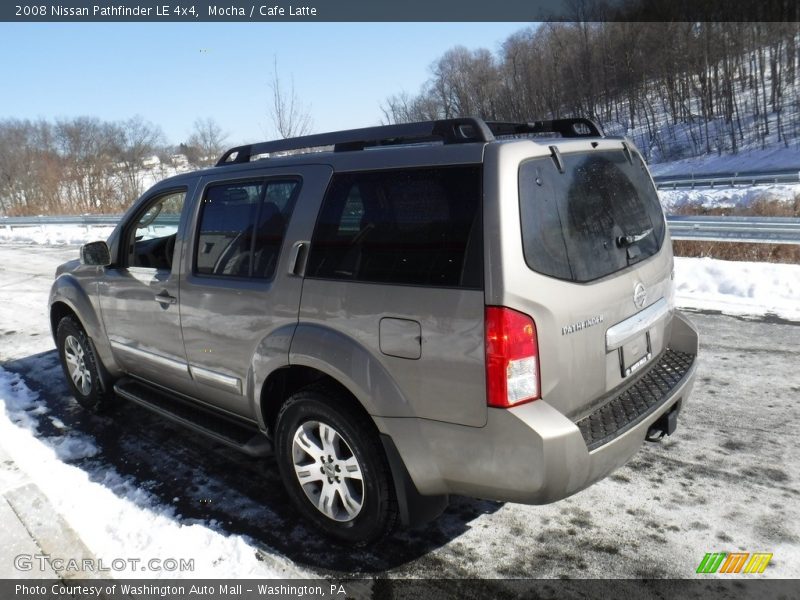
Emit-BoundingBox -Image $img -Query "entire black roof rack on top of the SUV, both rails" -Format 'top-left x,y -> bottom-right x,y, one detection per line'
217,117 -> 603,167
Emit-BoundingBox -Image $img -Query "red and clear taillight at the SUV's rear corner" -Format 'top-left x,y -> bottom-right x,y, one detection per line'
485,306 -> 540,408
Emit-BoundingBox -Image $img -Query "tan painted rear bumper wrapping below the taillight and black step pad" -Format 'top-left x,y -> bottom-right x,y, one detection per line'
375,315 -> 698,504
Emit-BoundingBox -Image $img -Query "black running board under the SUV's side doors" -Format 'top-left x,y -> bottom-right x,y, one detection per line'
114,377 -> 272,457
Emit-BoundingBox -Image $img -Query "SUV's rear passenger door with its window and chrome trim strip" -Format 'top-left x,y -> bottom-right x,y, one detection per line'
180,165 -> 331,418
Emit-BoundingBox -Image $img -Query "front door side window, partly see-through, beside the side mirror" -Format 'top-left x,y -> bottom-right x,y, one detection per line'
128,190 -> 186,271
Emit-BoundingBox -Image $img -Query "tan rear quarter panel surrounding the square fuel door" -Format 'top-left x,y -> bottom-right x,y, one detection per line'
291,278 -> 486,427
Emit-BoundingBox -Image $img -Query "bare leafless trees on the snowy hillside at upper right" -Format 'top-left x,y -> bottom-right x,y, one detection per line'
381,21 -> 800,160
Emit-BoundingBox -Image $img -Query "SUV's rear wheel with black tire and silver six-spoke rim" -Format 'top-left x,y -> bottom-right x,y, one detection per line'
275,386 -> 397,545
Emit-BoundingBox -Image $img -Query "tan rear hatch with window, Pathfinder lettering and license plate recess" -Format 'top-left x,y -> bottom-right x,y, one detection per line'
487,140 -> 672,421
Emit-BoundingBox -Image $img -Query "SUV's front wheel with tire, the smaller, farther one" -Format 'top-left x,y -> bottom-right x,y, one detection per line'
56,317 -> 114,412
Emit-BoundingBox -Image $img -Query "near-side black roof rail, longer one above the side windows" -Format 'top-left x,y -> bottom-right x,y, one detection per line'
217,117 -> 494,167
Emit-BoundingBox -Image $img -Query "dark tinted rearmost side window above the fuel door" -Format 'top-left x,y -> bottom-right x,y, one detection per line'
306,166 -> 483,288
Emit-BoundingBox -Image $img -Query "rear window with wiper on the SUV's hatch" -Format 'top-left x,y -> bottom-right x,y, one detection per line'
519,150 -> 665,282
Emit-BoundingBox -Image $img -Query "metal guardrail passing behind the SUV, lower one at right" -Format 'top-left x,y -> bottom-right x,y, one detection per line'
0,215 -> 800,244
